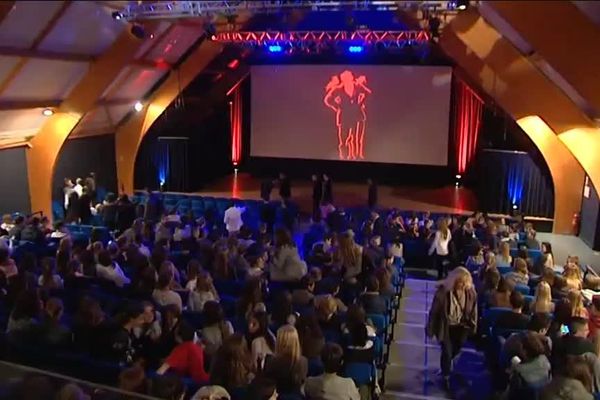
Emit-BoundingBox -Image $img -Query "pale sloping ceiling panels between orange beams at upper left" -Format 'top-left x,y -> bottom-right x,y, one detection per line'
0,1 -> 211,147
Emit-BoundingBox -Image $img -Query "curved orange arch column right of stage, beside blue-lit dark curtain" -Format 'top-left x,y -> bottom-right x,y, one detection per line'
440,25 -> 585,233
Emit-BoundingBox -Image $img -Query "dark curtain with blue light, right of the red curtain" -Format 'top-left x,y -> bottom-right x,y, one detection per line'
477,149 -> 554,218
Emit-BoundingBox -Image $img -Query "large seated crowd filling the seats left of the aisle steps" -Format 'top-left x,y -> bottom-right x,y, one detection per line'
0,180 -> 400,399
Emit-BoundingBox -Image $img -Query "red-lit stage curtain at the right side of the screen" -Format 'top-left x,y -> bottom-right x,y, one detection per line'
454,78 -> 483,175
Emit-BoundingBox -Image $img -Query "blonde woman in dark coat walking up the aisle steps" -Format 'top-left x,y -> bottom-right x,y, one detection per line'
426,267 -> 477,385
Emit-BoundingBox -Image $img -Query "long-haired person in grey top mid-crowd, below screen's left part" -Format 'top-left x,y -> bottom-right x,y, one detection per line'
269,228 -> 307,282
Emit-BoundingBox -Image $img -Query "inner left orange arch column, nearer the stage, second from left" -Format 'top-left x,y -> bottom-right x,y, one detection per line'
115,41 -> 223,195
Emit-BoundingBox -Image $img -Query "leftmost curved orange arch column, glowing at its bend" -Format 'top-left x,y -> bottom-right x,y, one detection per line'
27,23 -> 156,217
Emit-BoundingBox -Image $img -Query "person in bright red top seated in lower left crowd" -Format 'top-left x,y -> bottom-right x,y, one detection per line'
156,326 -> 210,384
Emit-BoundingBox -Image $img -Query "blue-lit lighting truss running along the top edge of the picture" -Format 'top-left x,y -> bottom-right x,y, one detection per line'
121,0 -> 456,21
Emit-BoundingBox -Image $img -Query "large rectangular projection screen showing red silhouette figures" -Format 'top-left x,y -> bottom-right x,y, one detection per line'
250,65 -> 452,166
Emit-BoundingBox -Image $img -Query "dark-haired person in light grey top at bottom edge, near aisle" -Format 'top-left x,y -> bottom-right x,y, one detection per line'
304,343 -> 360,400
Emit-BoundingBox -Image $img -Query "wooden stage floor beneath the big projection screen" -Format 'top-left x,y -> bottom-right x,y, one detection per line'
190,173 -> 477,214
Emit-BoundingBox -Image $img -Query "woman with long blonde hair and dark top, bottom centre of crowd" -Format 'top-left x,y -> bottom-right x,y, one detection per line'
264,325 -> 308,394
